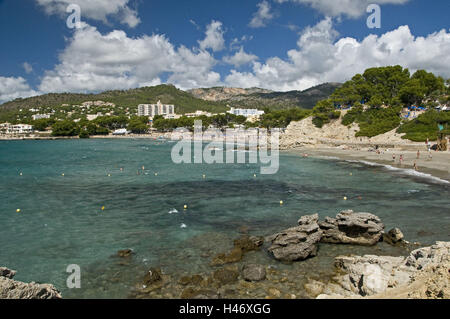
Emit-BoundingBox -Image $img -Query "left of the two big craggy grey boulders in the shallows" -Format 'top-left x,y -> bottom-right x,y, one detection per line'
267,214 -> 322,261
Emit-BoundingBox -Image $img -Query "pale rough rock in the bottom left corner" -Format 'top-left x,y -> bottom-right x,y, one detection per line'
0,268 -> 62,299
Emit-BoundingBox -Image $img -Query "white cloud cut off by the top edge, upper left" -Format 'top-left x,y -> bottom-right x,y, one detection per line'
36,0 -> 141,28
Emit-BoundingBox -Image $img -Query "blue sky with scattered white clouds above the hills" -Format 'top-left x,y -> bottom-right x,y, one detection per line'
0,0 -> 450,102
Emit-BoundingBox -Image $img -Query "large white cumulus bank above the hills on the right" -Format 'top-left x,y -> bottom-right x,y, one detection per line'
225,18 -> 450,91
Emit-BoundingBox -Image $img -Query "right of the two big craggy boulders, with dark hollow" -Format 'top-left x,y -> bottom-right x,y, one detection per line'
319,210 -> 384,246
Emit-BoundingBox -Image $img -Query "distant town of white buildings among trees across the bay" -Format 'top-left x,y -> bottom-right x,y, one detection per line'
0,100 -> 265,137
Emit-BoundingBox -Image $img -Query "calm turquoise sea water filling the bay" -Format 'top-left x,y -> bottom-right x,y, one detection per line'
0,140 -> 450,298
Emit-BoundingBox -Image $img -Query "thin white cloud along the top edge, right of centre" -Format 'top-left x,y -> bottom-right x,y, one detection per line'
275,0 -> 409,18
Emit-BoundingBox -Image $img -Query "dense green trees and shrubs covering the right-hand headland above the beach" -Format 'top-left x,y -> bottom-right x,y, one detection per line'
312,65 -> 449,141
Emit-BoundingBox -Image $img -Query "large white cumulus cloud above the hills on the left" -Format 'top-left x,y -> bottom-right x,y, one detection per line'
39,24 -> 220,92
